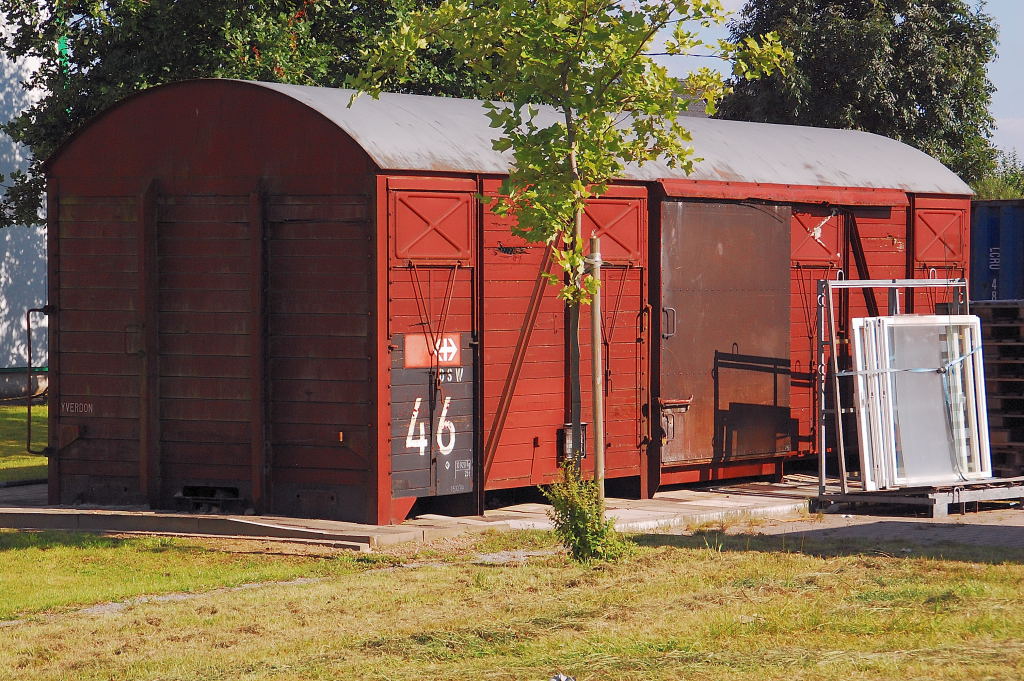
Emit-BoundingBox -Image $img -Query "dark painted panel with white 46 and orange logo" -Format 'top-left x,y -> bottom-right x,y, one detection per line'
391,333 -> 476,498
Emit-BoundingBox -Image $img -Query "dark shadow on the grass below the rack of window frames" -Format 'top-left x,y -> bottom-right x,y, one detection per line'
632,520 -> 1024,564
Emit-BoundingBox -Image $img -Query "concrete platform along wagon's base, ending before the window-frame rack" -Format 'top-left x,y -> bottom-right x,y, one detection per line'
0,480 -> 813,550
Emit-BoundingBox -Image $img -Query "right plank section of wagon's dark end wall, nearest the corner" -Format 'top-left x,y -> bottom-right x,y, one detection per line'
266,195 -> 377,520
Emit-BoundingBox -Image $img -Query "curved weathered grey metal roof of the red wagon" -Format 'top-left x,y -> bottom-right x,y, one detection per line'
244,81 -> 973,195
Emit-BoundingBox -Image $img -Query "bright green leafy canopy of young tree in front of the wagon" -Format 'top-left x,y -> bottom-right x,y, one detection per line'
350,0 -> 786,303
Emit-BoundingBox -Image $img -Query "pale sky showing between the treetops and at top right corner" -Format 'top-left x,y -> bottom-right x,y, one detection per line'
664,0 -> 1024,157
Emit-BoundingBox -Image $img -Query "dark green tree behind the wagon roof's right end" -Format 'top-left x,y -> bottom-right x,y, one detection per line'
720,0 -> 997,182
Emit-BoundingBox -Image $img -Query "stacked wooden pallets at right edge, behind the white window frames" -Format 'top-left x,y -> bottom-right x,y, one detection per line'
971,300 -> 1024,477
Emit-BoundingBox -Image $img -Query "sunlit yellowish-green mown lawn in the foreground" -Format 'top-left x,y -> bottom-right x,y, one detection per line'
0,533 -> 1024,681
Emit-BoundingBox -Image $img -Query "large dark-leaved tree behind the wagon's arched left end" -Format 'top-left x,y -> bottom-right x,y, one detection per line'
0,0 -> 475,227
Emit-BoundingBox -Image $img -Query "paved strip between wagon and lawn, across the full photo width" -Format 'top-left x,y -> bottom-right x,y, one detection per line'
0,475 -> 1024,551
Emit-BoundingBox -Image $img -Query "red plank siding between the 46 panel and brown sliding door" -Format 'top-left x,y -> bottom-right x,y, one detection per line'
483,191 -> 647,488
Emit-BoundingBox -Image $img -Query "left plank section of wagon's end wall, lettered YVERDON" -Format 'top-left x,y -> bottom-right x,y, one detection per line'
49,193 -> 146,504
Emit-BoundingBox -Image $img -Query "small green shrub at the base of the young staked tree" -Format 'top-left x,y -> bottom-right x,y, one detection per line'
541,461 -> 629,562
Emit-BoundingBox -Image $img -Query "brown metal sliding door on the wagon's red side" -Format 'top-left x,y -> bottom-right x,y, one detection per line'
659,202 -> 792,465
